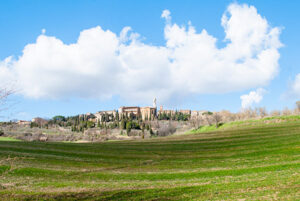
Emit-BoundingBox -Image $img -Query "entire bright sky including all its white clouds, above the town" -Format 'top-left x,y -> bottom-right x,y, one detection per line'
0,0 -> 300,120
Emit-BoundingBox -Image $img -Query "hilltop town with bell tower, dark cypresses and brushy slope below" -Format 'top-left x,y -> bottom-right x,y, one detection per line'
2,98 -> 212,141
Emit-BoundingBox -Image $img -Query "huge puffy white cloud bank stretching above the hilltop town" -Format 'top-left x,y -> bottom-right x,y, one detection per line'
0,3 -> 281,102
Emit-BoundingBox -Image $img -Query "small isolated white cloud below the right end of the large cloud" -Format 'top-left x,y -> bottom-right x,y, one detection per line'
240,88 -> 266,109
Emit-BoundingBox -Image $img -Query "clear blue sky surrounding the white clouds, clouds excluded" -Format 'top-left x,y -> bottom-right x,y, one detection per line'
0,0 -> 300,119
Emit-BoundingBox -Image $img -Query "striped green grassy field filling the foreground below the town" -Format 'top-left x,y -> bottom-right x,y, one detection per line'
0,121 -> 300,200
